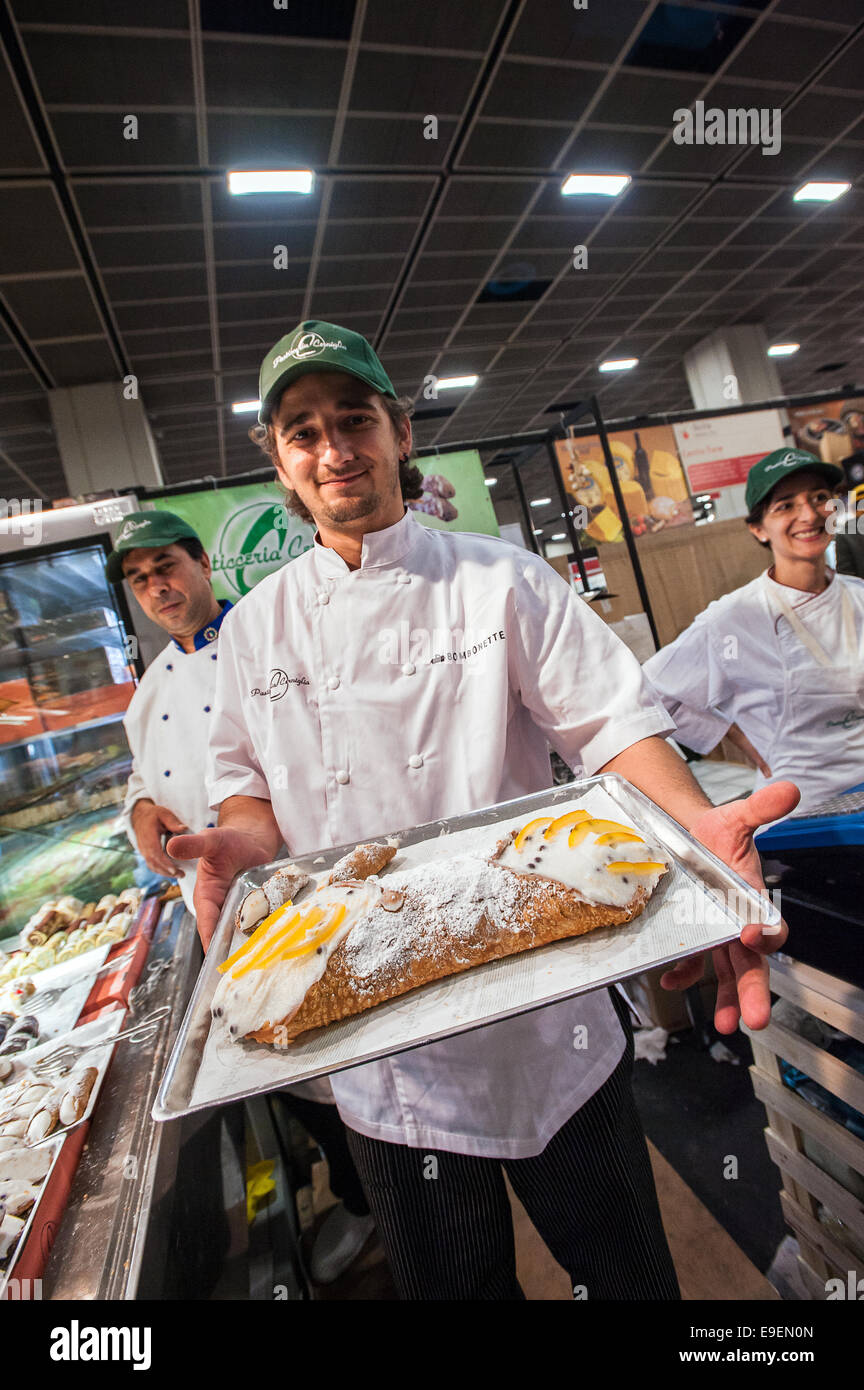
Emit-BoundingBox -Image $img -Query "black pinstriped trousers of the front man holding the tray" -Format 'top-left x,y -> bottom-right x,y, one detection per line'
346,990 -> 681,1301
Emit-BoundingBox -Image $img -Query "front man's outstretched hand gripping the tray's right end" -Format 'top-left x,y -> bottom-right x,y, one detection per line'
660,781 -> 800,1033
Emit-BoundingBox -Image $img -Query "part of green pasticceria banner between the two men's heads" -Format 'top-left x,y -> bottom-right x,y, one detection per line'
153,482 -> 315,603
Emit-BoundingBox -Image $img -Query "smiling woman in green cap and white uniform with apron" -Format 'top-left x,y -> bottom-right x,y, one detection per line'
643,449 -> 864,809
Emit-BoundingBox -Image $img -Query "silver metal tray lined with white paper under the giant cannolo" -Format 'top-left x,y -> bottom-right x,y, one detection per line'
153,774 -> 781,1120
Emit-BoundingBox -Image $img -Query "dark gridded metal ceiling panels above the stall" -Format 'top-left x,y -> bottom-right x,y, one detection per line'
0,0 -> 864,496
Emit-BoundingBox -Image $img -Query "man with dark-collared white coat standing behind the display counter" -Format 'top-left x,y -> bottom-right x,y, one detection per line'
106,512 -> 374,1283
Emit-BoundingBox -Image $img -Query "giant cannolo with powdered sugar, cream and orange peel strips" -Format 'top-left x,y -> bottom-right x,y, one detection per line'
213,810 -> 668,1045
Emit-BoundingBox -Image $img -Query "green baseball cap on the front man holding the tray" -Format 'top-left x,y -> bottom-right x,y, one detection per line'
258,318 -> 396,425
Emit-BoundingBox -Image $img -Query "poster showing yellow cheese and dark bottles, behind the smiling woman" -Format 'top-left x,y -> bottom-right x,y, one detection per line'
556,425 -> 693,543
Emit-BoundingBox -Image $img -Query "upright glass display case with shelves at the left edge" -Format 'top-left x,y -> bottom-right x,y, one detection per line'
0,538 -> 138,937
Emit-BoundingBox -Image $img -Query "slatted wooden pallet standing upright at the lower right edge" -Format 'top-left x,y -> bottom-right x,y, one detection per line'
745,955 -> 864,1300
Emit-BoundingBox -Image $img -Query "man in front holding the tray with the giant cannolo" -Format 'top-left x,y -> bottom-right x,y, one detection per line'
169,321 -> 797,1300
